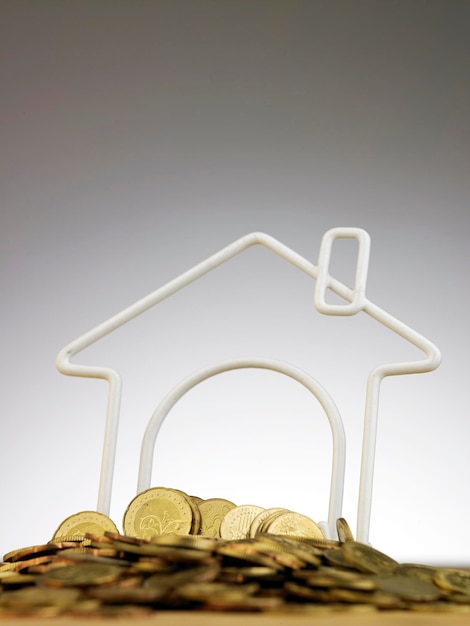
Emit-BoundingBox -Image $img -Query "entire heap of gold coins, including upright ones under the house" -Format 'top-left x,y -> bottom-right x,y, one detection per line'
0,487 -> 470,617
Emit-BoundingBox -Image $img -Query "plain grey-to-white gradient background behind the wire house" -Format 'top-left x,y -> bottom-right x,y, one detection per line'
0,0 -> 470,563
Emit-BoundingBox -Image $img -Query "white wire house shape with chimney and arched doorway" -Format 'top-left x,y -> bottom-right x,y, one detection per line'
56,227 -> 441,543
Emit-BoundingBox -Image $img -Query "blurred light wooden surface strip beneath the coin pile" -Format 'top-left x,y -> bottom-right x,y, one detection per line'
0,611 -> 470,626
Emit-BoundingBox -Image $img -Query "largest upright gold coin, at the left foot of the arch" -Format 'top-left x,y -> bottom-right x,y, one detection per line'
123,487 -> 193,539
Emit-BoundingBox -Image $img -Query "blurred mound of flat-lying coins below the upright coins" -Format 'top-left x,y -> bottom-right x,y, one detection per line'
0,530 -> 470,617
